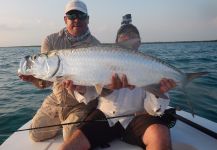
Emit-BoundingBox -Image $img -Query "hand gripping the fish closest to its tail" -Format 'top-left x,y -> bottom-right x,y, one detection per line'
160,78 -> 176,94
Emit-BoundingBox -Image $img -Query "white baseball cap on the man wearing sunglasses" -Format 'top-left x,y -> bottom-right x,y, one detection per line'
65,0 -> 88,14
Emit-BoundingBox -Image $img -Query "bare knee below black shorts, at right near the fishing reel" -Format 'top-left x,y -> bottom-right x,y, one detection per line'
142,124 -> 172,150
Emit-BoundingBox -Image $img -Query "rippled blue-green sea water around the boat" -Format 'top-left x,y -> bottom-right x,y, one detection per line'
0,42 -> 217,144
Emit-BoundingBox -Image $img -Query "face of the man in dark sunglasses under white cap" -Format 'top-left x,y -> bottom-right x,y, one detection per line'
64,10 -> 89,36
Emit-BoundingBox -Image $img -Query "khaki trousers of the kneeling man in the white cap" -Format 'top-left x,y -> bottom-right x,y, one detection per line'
29,94 -> 97,142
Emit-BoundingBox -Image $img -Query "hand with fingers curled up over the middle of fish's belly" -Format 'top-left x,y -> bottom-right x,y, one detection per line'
108,74 -> 135,90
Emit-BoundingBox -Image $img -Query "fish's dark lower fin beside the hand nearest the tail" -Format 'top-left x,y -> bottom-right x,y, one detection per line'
143,83 -> 169,99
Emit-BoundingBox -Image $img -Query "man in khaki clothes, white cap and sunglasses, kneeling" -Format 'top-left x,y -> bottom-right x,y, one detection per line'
20,0 -> 99,141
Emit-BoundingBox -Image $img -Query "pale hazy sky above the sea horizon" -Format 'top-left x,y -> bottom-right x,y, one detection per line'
0,0 -> 217,47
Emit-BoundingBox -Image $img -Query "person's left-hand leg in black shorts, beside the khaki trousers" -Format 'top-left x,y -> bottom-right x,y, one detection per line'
60,110 -> 123,150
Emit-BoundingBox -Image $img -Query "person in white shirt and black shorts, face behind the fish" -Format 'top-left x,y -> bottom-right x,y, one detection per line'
60,15 -> 176,150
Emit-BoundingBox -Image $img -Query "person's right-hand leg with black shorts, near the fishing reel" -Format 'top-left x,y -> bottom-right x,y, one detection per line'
124,115 -> 173,150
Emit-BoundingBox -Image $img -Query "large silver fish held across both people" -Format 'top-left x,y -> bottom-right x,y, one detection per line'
18,45 -> 205,98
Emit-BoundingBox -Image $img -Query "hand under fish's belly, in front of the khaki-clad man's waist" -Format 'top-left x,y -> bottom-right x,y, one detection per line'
63,80 -> 86,95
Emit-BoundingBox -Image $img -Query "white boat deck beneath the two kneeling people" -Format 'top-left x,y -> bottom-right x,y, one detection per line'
0,111 -> 217,150
